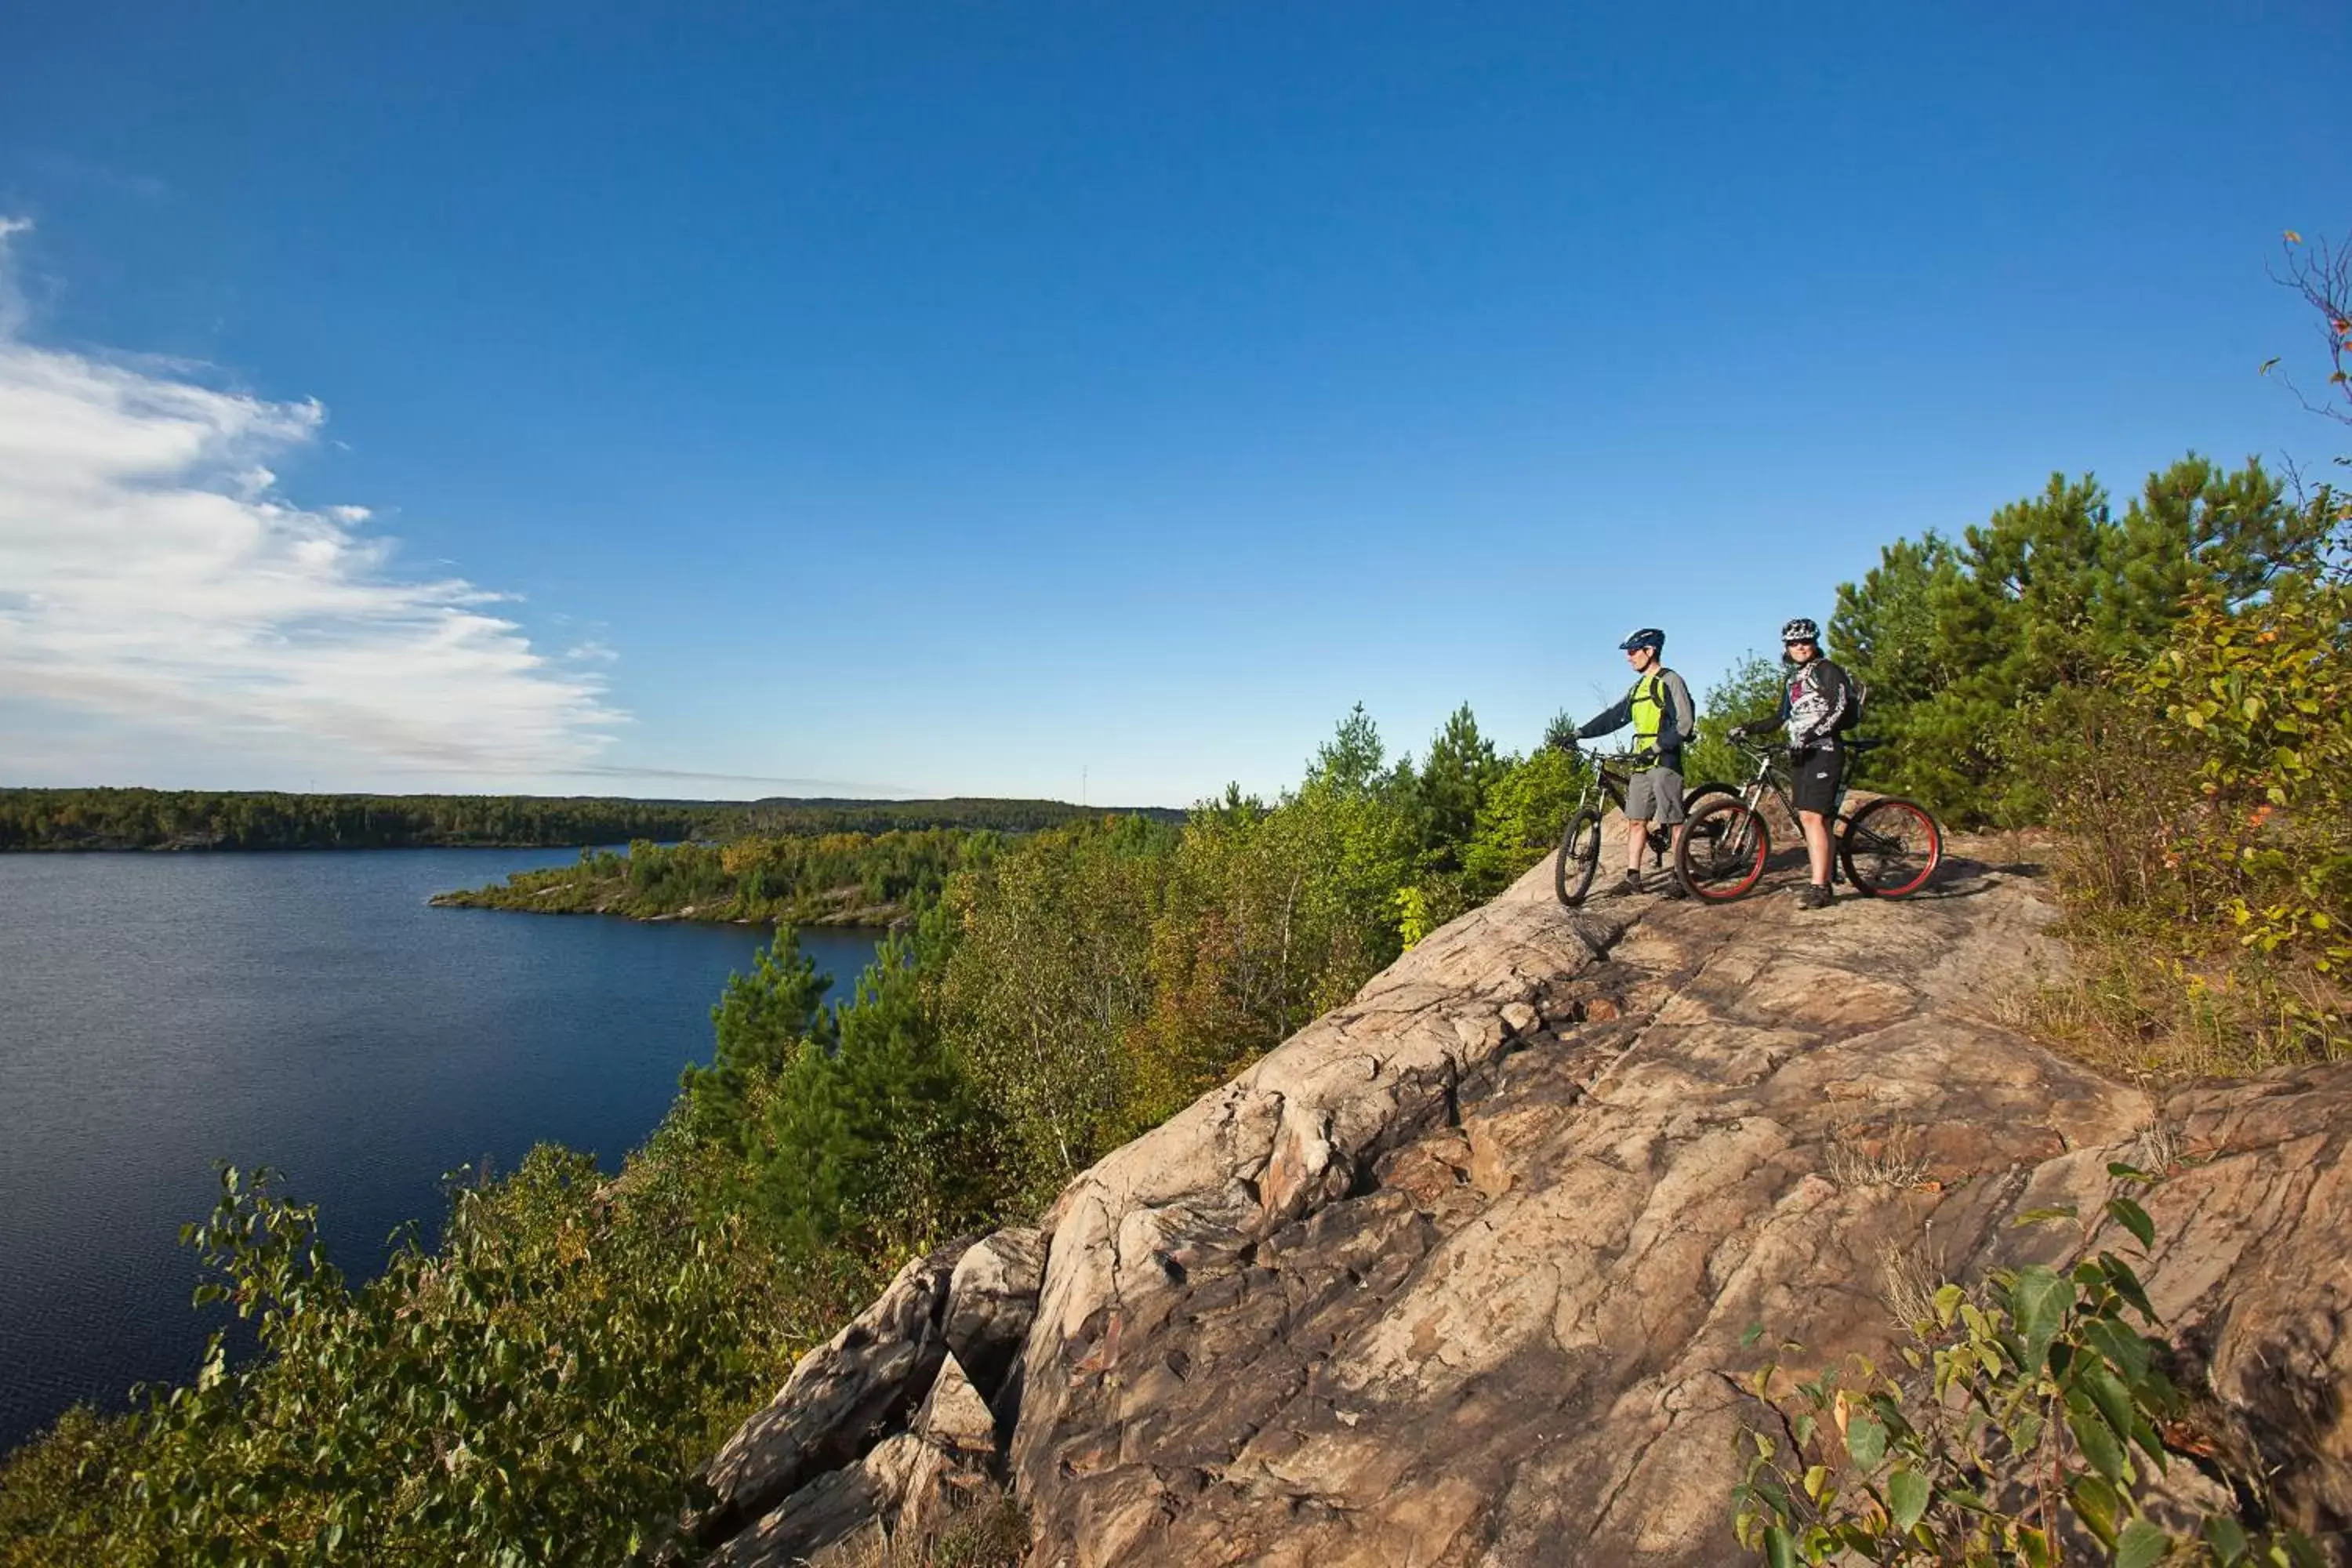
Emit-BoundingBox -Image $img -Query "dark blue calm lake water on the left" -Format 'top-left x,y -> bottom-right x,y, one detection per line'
0,848 -> 873,1448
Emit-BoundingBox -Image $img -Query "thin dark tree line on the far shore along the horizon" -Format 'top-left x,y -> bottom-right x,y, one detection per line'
0,787 -> 1181,851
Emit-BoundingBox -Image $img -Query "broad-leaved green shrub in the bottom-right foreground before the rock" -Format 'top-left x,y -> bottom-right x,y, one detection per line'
1733,1185 -> 2321,1568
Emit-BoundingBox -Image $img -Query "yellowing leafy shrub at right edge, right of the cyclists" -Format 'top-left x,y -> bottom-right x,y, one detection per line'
2011,572 -> 2352,1076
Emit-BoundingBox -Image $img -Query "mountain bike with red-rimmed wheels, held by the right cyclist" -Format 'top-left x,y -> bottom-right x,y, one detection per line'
1675,741 -> 1943,902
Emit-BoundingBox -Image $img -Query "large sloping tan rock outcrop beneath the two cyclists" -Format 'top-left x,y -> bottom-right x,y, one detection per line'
696,827 -> 2352,1568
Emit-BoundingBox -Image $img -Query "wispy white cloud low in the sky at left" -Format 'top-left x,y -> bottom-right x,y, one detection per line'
0,219 -> 623,783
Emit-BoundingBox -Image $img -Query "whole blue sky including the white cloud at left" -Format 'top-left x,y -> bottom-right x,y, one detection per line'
0,0 -> 2352,804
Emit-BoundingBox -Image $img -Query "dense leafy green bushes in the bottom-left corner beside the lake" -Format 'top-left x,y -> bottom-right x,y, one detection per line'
5,1147 -> 790,1568
